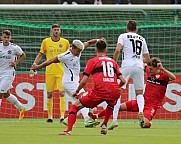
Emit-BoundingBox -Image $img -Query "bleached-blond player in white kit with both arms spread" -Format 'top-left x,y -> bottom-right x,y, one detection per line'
31,39 -> 102,127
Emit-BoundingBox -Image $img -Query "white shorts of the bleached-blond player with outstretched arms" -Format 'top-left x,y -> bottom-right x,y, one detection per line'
62,82 -> 85,102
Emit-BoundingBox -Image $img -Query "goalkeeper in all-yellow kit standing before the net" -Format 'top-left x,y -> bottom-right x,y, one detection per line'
30,24 -> 70,123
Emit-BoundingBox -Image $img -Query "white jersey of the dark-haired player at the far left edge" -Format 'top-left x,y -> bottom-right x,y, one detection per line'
0,42 -> 23,76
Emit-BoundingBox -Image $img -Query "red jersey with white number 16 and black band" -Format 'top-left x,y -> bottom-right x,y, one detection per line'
83,56 -> 121,98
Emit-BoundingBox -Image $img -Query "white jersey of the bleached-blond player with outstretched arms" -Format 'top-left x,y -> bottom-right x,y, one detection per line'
58,49 -> 81,83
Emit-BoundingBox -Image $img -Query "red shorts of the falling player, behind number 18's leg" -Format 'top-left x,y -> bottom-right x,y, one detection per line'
126,100 -> 157,121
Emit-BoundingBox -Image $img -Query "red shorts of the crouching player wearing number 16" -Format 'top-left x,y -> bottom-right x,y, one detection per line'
79,90 -> 119,108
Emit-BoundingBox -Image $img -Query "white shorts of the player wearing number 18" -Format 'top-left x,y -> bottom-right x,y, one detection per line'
120,66 -> 144,90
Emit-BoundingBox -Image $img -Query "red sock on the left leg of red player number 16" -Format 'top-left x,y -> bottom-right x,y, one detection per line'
67,105 -> 79,131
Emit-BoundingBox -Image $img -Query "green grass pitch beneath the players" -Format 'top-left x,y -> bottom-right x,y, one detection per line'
0,119 -> 181,144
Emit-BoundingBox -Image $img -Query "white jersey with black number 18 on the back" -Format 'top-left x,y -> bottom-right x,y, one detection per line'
118,32 -> 149,69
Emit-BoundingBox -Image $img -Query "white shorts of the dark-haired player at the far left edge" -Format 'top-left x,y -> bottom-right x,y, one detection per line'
0,76 -> 15,93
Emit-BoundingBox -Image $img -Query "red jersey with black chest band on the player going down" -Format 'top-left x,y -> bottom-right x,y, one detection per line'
144,68 -> 169,107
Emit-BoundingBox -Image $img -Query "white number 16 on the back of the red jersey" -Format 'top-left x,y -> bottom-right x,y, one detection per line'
102,61 -> 114,77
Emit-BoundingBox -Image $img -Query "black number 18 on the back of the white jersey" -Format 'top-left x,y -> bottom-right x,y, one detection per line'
130,39 -> 142,55
